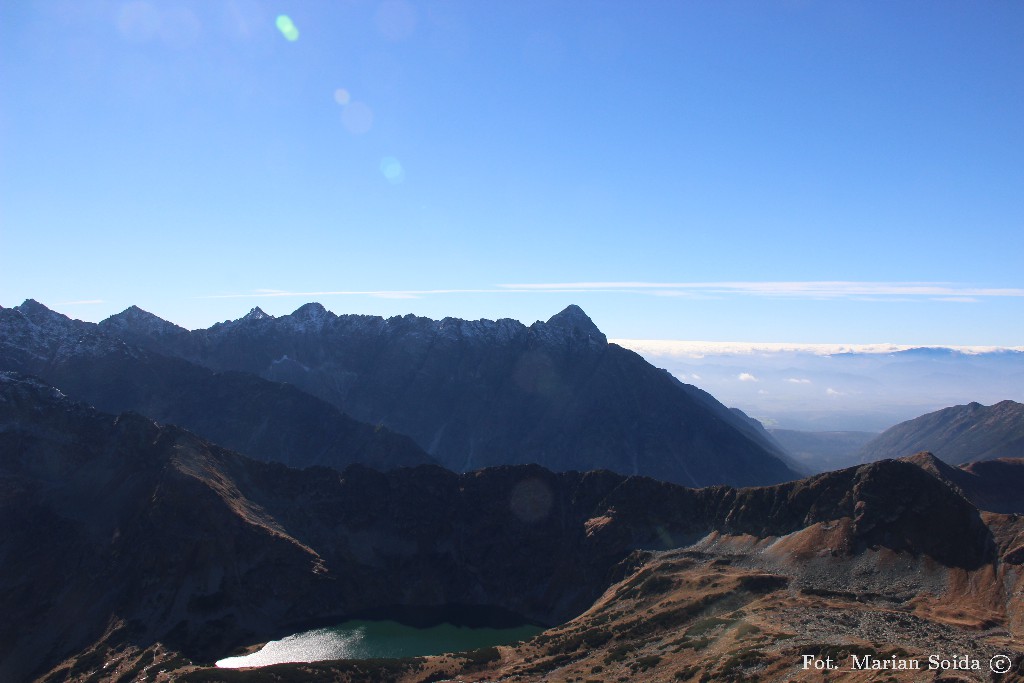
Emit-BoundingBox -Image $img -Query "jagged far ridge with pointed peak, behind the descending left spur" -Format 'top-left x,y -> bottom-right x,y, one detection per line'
99,303 -> 798,486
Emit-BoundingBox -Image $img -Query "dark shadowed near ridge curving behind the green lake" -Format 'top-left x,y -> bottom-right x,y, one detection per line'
0,373 -> 1024,681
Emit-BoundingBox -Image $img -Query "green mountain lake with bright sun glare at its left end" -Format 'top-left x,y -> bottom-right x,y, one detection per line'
211,620 -> 544,669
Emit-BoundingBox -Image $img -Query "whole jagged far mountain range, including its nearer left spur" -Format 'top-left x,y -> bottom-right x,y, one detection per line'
0,300 -> 799,486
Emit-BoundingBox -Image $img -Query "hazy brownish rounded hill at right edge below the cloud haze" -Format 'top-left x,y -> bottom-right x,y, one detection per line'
858,400 -> 1024,465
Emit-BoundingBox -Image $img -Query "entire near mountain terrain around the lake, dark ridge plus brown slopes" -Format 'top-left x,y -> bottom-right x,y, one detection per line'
0,372 -> 1024,682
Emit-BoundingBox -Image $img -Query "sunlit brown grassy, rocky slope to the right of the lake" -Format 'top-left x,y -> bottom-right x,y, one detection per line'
108,514 -> 1024,683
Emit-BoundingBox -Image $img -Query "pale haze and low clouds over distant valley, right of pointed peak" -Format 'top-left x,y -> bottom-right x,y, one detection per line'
611,339 -> 1024,431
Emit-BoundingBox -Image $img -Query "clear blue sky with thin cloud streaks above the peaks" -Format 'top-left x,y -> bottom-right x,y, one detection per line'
0,0 -> 1024,345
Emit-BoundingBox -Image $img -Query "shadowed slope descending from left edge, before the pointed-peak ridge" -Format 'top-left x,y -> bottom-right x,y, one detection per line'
0,301 -> 433,469
